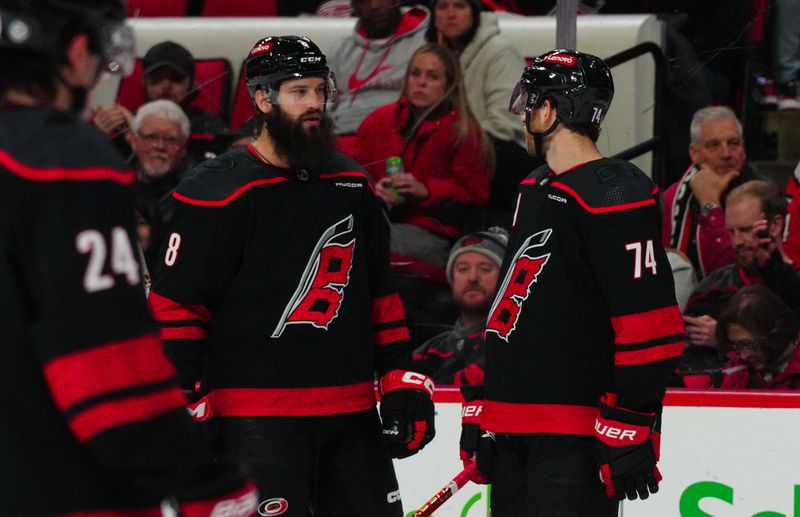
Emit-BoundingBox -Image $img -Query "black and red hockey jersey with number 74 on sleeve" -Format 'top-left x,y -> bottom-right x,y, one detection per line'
482,159 -> 684,436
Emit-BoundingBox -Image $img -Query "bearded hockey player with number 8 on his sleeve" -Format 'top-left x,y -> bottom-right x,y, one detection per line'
150,36 -> 434,517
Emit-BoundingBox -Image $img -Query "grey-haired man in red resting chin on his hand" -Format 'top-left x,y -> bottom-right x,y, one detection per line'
662,106 -> 756,278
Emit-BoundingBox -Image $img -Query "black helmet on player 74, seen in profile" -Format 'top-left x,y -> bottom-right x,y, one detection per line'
509,49 -> 614,126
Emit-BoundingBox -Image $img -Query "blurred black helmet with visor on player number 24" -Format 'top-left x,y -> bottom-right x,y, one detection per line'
0,0 -> 135,75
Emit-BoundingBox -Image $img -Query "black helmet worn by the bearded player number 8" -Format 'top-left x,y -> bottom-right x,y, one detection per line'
244,36 -> 336,103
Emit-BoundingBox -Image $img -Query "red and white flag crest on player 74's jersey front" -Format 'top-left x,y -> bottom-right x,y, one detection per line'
486,229 -> 553,343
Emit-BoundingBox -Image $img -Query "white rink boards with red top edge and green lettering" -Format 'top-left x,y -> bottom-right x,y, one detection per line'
395,387 -> 800,517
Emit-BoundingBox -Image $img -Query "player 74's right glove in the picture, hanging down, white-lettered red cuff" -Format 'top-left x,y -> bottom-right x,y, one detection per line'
594,393 -> 661,500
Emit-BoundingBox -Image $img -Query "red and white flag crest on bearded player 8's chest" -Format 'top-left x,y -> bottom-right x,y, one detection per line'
272,215 -> 356,338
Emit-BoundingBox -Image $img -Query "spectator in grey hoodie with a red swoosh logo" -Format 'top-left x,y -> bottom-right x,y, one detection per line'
330,0 -> 430,153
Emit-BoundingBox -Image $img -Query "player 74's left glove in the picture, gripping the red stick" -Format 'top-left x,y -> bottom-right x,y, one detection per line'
459,386 -> 495,483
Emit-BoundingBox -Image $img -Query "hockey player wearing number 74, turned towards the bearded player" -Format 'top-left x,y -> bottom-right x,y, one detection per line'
461,50 -> 684,517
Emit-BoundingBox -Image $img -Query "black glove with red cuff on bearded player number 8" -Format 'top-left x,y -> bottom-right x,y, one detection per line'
379,370 -> 436,458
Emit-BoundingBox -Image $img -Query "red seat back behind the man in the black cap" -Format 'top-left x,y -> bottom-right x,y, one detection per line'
117,58 -> 233,121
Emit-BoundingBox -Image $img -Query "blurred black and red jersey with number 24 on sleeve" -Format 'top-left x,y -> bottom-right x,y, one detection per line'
0,107 -> 256,517
